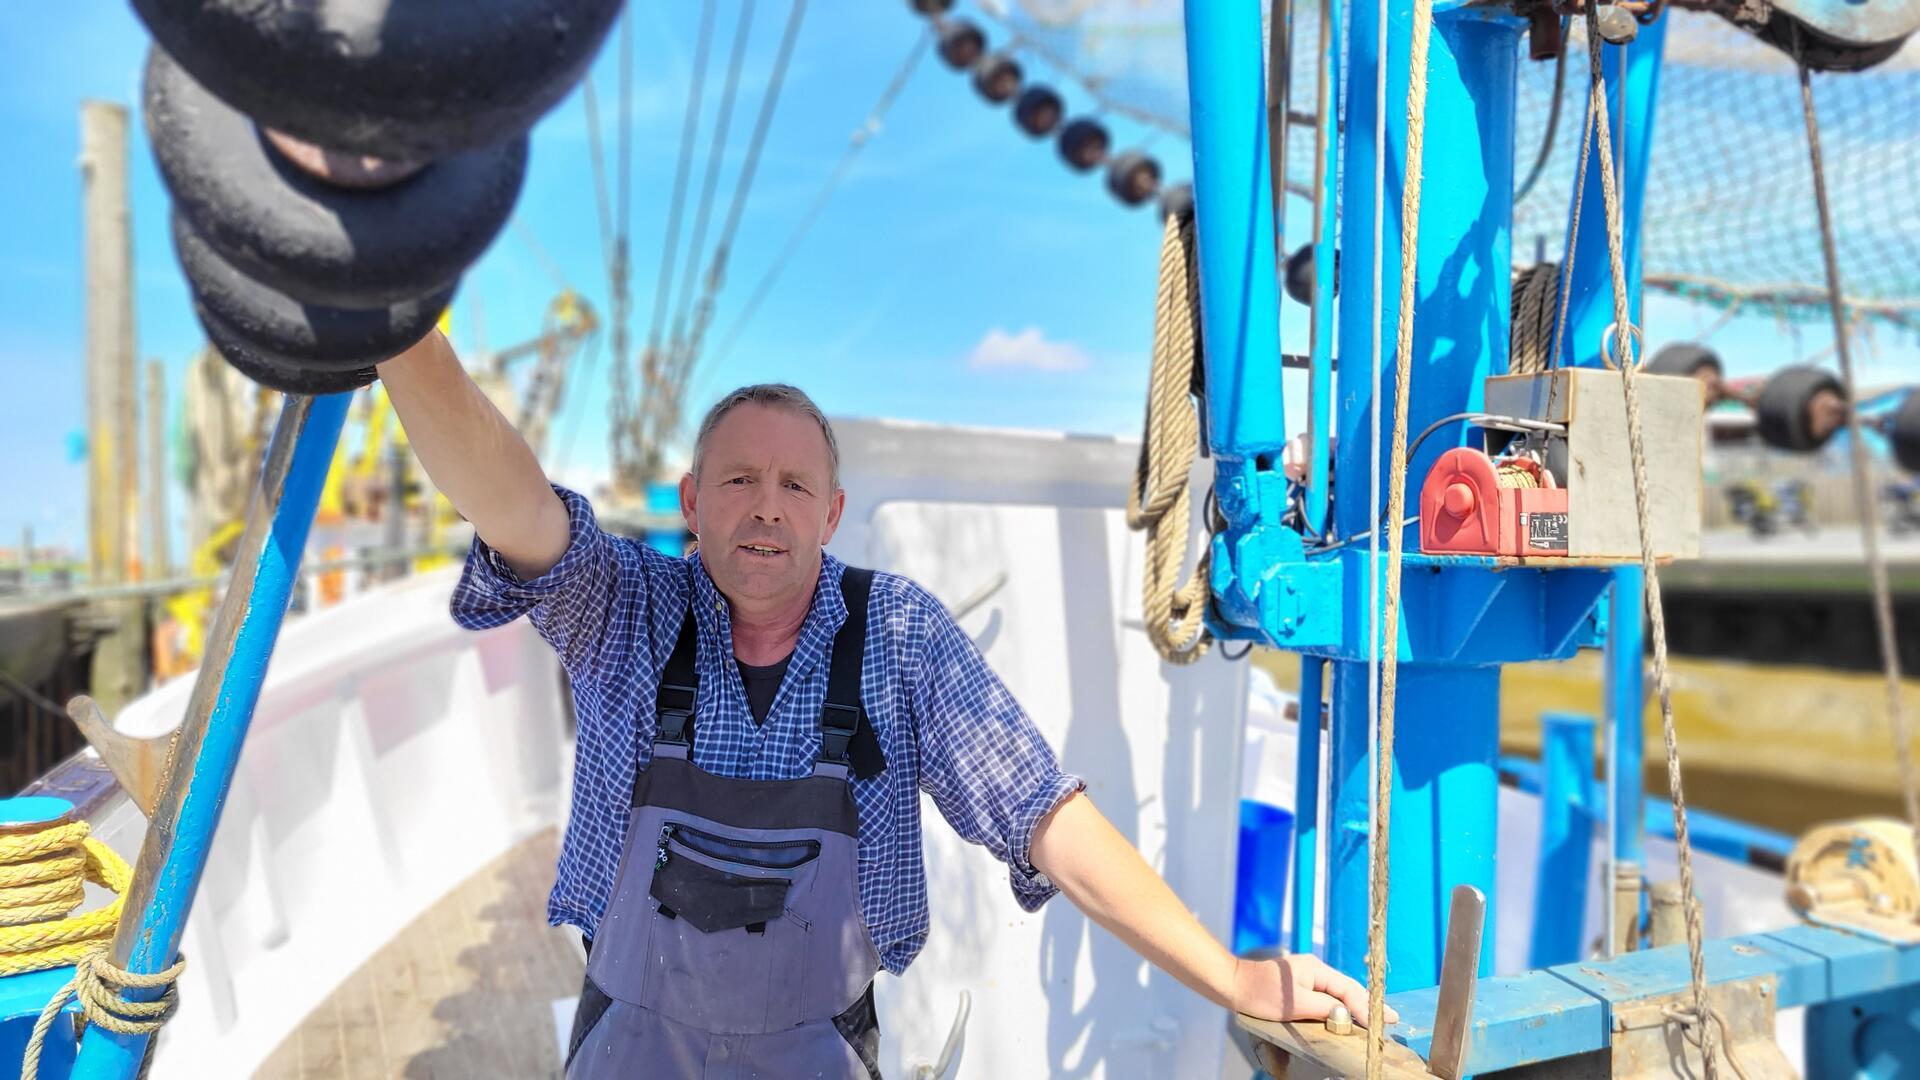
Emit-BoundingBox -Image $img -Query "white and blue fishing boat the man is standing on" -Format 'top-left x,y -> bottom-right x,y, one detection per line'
0,0 -> 1920,1078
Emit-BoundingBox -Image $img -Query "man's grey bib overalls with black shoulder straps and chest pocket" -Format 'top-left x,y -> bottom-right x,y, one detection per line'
566,569 -> 879,1080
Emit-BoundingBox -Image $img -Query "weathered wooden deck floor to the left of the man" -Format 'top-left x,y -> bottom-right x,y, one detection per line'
255,828 -> 586,1080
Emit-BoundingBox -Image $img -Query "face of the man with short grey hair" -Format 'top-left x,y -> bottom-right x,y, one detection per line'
680,402 -> 847,605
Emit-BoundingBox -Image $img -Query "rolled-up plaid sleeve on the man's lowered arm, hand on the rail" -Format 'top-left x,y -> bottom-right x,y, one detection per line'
912,596 -> 1087,911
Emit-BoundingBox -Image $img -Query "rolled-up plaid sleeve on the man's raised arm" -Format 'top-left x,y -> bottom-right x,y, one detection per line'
449,484 -> 643,678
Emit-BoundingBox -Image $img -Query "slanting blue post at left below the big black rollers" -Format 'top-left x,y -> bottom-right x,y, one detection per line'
73,394 -> 353,1080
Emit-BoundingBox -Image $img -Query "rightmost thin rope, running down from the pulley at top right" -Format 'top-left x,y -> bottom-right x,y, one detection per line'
1793,27 -> 1920,891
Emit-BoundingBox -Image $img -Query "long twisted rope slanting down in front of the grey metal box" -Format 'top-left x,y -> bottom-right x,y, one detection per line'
1580,4 -> 1720,1080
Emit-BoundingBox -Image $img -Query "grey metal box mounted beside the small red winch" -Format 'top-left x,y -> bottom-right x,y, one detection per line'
1486,367 -> 1707,561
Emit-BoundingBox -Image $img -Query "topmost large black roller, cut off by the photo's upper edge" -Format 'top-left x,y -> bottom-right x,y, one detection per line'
132,0 -> 620,161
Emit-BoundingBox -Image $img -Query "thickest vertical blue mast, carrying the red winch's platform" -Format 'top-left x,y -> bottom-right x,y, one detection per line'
1327,0 -> 1524,990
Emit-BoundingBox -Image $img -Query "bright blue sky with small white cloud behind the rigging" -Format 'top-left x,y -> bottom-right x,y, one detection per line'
0,0 -> 1889,550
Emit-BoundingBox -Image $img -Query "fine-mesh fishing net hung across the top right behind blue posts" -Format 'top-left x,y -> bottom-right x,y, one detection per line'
981,0 -> 1920,334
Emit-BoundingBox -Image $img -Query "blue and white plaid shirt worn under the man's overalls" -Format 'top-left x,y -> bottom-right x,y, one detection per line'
441,486 -> 1085,974
